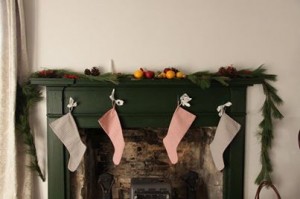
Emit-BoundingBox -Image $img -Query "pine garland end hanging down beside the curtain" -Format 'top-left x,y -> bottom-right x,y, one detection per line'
15,83 -> 46,181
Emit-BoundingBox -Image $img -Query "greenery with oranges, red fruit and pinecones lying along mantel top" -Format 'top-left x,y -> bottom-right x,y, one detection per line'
31,65 -> 262,89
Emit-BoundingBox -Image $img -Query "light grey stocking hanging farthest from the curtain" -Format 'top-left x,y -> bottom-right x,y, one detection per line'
210,113 -> 241,171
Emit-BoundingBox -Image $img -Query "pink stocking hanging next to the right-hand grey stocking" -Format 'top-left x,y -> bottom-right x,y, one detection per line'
163,106 -> 196,164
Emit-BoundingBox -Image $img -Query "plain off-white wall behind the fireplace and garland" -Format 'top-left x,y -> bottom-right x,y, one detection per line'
24,0 -> 300,199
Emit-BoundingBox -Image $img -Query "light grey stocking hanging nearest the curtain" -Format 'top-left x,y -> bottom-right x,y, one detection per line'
49,112 -> 86,171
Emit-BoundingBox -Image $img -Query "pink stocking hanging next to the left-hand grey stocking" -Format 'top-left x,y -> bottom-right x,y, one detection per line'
98,107 -> 125,165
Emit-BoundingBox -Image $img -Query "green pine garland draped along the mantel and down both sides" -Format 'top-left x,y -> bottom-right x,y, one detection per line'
16,66 -> 283,184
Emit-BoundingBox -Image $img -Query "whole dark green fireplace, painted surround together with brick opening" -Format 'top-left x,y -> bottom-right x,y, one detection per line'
31,78 -> 259,199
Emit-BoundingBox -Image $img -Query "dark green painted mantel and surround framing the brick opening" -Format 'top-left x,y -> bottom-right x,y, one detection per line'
31,78 -> 261,199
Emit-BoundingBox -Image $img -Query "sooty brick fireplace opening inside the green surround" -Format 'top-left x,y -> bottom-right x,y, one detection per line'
70,127 -> 223,199
